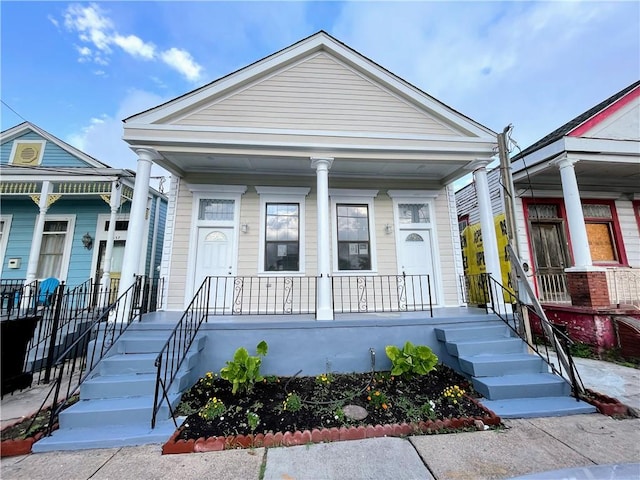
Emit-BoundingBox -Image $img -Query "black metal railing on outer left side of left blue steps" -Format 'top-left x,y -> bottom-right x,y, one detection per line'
29,276 -> 150,435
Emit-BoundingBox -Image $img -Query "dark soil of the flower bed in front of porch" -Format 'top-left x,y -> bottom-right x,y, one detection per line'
177,365 -> 486,440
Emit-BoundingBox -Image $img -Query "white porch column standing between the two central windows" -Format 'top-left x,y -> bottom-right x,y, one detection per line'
311,157 -> 333,320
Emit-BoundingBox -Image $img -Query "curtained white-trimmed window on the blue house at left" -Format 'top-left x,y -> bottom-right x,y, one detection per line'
36,218 -> 72,278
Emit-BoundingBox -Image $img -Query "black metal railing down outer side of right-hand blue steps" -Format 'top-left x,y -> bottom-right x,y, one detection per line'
485,266 -> 584,400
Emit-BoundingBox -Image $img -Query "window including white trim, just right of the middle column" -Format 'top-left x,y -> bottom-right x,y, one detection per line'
329,189 -> 378,272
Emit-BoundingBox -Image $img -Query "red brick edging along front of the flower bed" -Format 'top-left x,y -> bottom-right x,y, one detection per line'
162,398 -> 501,455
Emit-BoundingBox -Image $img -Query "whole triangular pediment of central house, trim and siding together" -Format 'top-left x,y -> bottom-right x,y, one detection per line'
125,32 -> 495,138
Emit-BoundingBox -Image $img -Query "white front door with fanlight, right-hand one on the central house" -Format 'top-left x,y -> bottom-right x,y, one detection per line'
398,229 -> 437,310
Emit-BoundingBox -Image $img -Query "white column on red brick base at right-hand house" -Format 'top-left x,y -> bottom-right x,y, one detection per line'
552,157 -> 593,270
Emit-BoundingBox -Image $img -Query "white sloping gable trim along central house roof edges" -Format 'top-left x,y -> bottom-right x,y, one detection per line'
123,30 -> 496,138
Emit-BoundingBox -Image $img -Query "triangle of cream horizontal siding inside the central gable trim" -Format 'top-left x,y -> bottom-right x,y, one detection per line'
174,53 -> 460,136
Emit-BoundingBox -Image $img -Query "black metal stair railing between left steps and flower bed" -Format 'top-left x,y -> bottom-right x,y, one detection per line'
151,277 -> 213,428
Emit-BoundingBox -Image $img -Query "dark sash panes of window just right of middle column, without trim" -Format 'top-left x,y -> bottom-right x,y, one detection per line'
336,204 -> 371,270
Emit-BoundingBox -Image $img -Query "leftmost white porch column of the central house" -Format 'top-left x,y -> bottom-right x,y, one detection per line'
118,148 -> 157,296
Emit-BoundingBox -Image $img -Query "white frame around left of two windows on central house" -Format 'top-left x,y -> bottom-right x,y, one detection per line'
255,186 -> 311,277
